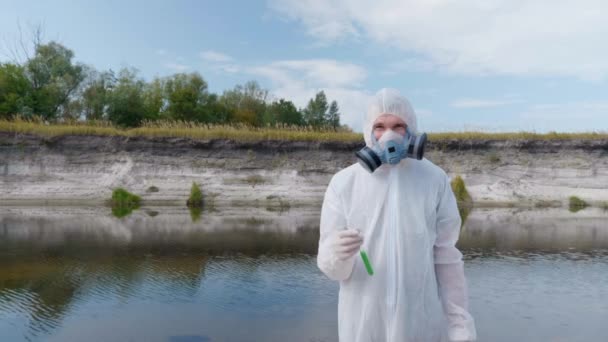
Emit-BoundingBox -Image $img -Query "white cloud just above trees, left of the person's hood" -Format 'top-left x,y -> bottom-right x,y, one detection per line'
247,59 -> 372,131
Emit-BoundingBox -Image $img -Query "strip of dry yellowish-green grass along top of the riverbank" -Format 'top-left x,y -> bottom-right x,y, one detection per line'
0,118 -> 608,142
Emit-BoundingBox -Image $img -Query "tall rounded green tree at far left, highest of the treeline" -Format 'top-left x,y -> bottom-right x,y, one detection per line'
25,42 -> 85,119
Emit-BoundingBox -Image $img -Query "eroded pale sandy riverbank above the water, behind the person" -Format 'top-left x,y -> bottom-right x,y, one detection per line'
0,131 -> 608,210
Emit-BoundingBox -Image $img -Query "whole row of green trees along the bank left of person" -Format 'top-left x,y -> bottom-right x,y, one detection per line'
0,42 -> 349,130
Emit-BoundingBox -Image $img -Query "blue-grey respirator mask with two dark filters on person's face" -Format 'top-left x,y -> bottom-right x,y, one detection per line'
355,128 -> 427,172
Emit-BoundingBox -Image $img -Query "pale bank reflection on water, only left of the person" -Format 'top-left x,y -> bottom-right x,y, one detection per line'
0,207 -> 319,255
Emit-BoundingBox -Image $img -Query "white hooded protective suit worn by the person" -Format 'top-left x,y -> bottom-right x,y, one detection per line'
317,89 -> 476,342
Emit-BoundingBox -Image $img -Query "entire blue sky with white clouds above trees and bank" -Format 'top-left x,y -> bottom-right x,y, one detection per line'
0,0 -> 608,133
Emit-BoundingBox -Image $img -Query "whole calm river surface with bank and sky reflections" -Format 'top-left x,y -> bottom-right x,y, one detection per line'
0,207 -> 608,342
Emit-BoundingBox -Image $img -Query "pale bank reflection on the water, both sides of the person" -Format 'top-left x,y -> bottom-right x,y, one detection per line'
0,207 -> 608,255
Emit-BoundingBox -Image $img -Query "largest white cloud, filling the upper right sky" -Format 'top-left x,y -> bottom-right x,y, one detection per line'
269,0 -> 608,80
